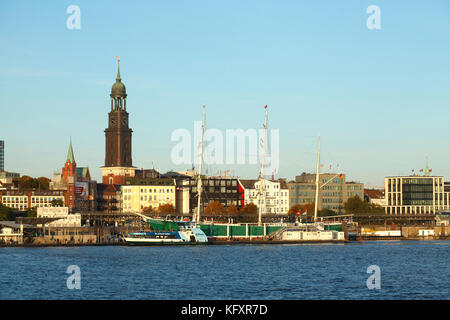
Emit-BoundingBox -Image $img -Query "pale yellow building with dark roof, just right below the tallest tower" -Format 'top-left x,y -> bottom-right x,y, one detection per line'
121,177 -> 177,212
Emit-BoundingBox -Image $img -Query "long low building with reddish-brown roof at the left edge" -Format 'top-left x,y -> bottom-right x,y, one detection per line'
0,190 -> 65,211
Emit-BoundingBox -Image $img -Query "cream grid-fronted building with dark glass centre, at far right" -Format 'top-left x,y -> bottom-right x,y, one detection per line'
384,175 -> 450,215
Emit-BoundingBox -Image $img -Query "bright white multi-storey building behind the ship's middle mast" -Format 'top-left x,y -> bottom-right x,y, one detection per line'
239,179 -> 290,214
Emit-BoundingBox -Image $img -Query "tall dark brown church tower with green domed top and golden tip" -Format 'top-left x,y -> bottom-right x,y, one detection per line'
101,62 -> 136,184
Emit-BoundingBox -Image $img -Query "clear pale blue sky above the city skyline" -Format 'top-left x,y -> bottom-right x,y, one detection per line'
0,0 -> 450,185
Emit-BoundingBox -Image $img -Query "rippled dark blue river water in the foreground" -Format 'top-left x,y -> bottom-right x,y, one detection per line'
0,241 -> 450,300
